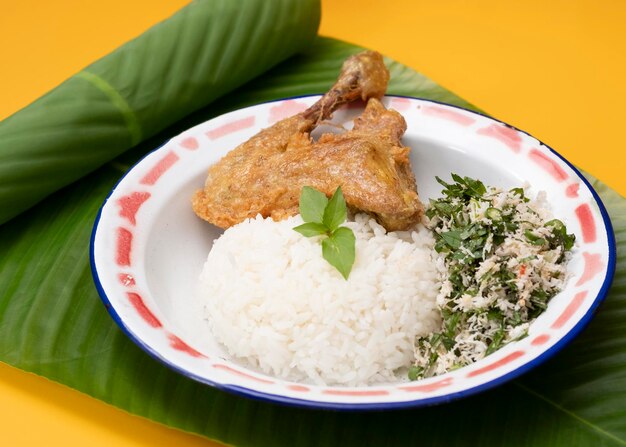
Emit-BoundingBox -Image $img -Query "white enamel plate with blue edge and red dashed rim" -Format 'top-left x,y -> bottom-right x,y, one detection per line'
91,96 -> 616,410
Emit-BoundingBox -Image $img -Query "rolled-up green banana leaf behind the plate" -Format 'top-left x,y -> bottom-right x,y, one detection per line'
0,0 -> 320,224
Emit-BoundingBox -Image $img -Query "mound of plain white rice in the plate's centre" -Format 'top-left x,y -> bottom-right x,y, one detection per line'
200,215 -> 441,386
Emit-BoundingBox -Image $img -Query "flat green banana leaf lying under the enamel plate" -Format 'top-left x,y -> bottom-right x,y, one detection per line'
0,38 -> 626,447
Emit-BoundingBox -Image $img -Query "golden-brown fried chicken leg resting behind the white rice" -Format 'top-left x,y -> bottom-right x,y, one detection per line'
192,51 -> 423,231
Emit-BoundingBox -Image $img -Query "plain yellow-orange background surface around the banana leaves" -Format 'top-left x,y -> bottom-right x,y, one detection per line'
0,0 -> 626,447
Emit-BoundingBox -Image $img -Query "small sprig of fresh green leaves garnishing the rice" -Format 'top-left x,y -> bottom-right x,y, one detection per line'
294,186 -> 356,279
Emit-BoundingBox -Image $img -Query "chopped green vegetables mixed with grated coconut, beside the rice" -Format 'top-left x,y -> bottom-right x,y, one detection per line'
409,174 -> 575,379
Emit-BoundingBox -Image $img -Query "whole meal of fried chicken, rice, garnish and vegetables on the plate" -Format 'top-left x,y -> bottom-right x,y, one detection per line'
192,51 -> 574,386
